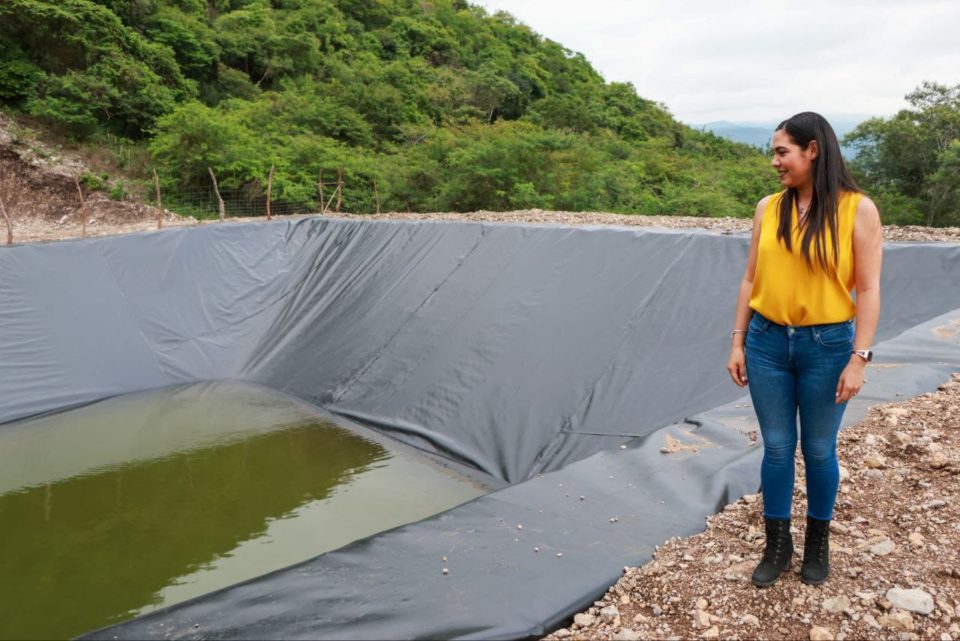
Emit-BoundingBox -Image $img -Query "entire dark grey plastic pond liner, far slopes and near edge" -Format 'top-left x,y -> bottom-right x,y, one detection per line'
0,218 -> 960,639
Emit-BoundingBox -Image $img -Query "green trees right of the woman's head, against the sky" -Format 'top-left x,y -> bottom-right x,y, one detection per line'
844,82 -> 960,226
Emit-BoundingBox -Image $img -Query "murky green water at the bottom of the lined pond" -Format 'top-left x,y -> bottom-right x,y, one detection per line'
0,382 -> 492,639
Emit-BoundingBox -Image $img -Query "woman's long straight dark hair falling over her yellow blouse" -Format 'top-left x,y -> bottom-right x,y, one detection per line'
775,111 -> 860,270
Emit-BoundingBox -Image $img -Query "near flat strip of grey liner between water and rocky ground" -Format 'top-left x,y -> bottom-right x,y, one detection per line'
86,309 -> 960,639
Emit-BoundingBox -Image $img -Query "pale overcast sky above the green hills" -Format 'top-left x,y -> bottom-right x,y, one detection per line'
473,0 -> 960,124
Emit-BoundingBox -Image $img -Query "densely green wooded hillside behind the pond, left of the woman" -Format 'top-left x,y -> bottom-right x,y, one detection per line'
0,0 -> 777,216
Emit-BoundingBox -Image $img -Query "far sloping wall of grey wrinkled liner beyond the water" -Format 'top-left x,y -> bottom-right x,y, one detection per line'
0,218 -> 960,482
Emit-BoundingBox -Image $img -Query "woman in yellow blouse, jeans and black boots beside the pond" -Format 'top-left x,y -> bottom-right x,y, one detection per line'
727,112 -> 883,586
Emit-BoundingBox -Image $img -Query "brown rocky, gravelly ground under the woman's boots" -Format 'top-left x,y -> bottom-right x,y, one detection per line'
545,374 -> 960,641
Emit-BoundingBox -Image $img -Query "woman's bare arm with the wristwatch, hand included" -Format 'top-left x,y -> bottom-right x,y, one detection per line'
836,196 -> 883,403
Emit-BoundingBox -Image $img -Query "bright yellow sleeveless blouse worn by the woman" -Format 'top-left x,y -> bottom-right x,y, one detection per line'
750,191 -> 862,326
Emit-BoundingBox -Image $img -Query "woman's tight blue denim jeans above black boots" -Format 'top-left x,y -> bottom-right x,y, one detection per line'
746,313 -> 853,520
